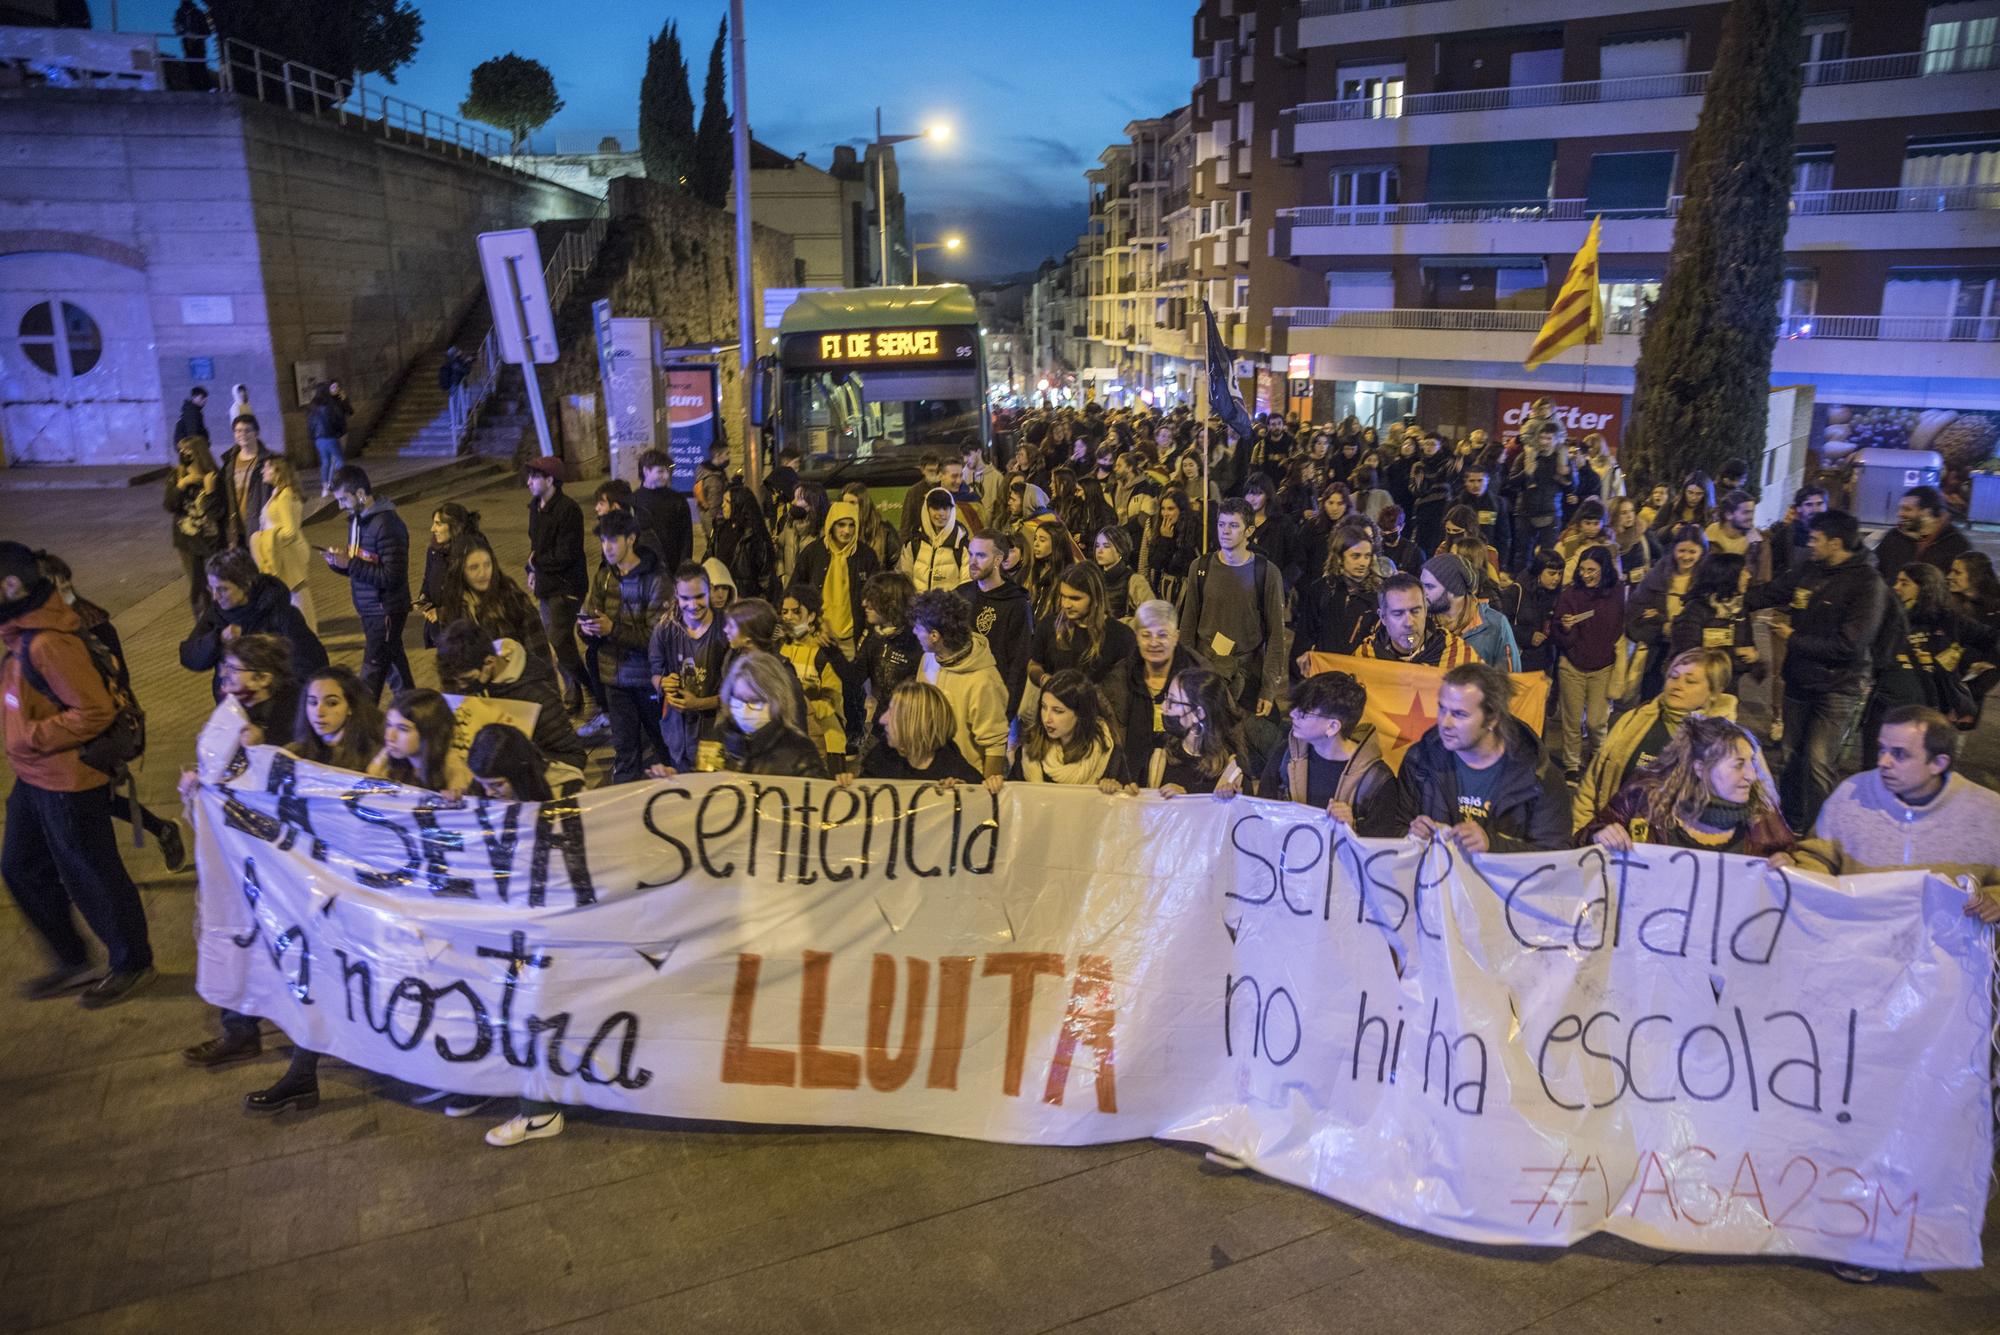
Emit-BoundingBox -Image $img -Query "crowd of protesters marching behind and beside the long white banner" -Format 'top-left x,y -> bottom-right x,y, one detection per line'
0,402 -> 2000,1167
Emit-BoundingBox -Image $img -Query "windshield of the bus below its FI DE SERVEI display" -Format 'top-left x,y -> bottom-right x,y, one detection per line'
782,366 -> 980,464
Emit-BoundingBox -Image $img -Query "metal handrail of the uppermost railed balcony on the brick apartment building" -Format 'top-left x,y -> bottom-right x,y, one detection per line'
1280,46 -> 2000,126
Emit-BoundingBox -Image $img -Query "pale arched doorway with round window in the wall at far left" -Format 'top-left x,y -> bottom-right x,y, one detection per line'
0,252 -> 168,464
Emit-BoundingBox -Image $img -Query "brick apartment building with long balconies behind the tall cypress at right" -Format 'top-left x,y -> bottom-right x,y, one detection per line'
1264,0 -> 2000,452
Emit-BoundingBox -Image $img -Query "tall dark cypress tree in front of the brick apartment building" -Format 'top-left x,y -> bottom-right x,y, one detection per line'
1626,0 -> 1806,482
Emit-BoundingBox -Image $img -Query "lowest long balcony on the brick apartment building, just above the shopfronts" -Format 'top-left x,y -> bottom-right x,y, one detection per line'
1272,306 -> 2000,393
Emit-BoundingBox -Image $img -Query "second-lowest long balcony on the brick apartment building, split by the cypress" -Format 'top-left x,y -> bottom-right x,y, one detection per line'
1278,186 -> 2000,258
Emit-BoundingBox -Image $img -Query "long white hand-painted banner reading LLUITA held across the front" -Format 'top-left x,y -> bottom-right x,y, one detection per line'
196,747 -> 1992,1269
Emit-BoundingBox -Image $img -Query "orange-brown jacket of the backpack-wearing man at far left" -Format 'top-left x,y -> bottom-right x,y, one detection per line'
0,580 -> 118,793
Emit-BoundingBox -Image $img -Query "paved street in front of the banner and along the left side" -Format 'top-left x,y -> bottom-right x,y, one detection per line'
0,473 -> 2000,1335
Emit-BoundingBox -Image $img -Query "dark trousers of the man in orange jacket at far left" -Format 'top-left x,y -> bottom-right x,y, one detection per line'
0,779 -> 152,973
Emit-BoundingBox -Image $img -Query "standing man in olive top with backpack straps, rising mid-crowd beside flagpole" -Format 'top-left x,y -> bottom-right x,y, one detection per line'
1180,500 -> 1284,713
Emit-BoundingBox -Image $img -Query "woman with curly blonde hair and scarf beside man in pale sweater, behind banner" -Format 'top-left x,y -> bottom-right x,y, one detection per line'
1576,715 -> 1798,865
